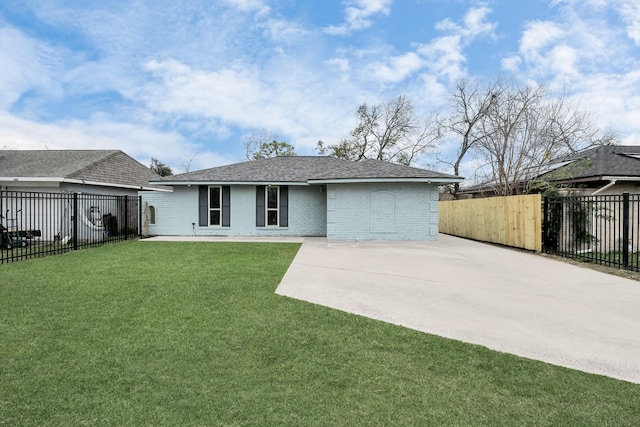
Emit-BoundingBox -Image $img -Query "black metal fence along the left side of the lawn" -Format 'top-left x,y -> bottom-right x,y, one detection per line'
0,191 -> 141,264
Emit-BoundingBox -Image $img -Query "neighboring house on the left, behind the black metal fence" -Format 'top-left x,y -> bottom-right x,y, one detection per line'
0,150 -> 171,241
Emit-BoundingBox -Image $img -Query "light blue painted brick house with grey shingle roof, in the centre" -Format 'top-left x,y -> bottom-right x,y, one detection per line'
142,156 -> 462,240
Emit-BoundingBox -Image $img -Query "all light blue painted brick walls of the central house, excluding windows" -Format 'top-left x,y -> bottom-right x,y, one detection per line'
141,183 -> 438,240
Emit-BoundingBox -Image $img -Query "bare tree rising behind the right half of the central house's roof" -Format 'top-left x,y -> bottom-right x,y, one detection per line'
317,95 -> 440,165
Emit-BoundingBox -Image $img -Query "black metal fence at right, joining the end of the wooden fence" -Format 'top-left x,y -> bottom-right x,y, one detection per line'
542,193 -> 640,271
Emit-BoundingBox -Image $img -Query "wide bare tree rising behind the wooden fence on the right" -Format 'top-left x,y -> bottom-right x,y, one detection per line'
477,81 -> 615,195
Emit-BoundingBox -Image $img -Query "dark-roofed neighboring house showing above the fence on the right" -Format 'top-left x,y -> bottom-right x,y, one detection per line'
460,145 -> 640,197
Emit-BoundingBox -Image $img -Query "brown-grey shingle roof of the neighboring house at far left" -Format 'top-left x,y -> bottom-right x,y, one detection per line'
0,150 -> 168,190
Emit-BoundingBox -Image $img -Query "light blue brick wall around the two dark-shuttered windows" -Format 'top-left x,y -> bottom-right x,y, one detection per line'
141,185 -> 327,236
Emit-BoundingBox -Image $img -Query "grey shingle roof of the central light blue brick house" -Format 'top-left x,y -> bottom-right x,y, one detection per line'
156,156 -> 462,185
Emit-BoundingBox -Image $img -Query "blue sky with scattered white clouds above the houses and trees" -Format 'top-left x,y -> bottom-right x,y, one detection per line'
0,0 -> 640,175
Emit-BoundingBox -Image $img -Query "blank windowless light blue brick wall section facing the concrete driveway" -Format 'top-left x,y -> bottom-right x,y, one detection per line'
327,183 -> 438,240
